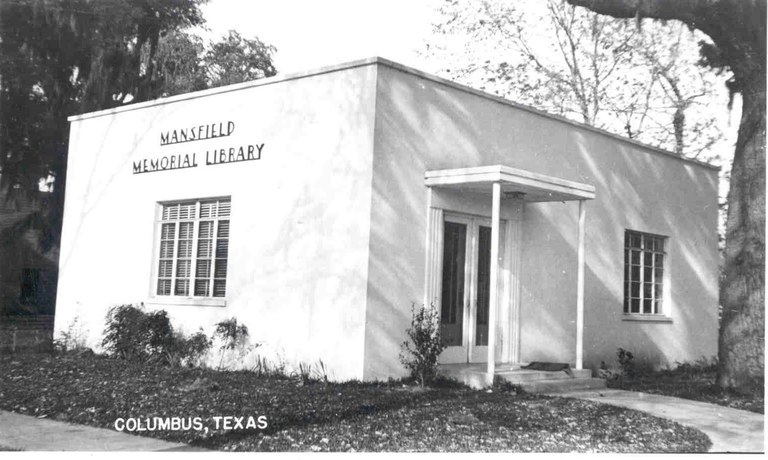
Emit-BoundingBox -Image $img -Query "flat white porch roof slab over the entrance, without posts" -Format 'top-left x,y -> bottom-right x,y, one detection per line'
424,165 -> 595,201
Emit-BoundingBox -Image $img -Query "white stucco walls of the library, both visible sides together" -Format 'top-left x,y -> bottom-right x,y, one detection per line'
55,61 -> 717,379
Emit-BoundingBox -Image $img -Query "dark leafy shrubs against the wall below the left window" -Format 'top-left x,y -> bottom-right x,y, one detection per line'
102,305 -> 211,366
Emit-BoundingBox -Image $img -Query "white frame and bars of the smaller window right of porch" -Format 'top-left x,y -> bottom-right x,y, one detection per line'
622,228 -> 671,322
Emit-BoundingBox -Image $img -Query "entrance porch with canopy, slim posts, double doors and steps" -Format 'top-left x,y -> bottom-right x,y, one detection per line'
424,165 -> 595,386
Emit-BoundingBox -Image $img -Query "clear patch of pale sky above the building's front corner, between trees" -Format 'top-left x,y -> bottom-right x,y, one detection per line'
199,0 -> 440,73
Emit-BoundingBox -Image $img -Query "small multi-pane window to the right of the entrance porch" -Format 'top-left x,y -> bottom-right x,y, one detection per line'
624,230 -> 666,315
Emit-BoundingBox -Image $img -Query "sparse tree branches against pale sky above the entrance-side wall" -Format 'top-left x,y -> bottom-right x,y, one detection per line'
425,0 -> 727,160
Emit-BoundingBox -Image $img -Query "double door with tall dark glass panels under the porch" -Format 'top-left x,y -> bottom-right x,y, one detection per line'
440,215 -> 504,364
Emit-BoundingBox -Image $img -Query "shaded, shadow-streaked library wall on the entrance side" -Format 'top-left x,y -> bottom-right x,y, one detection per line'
365,65 -> 718,378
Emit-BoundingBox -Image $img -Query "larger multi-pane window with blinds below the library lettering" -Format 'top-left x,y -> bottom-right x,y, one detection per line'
156,198 -> 231,297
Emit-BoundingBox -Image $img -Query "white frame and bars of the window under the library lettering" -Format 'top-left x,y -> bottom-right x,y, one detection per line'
147,196 -> 232,307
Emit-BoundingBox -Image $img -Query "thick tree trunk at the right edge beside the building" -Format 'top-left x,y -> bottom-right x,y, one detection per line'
717,73 -> 766,388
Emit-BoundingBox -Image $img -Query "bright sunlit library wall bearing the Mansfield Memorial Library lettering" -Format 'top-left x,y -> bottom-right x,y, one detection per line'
55,66 -> 376,379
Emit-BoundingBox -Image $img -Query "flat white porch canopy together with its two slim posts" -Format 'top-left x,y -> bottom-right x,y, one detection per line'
424,165 -> 595,378
